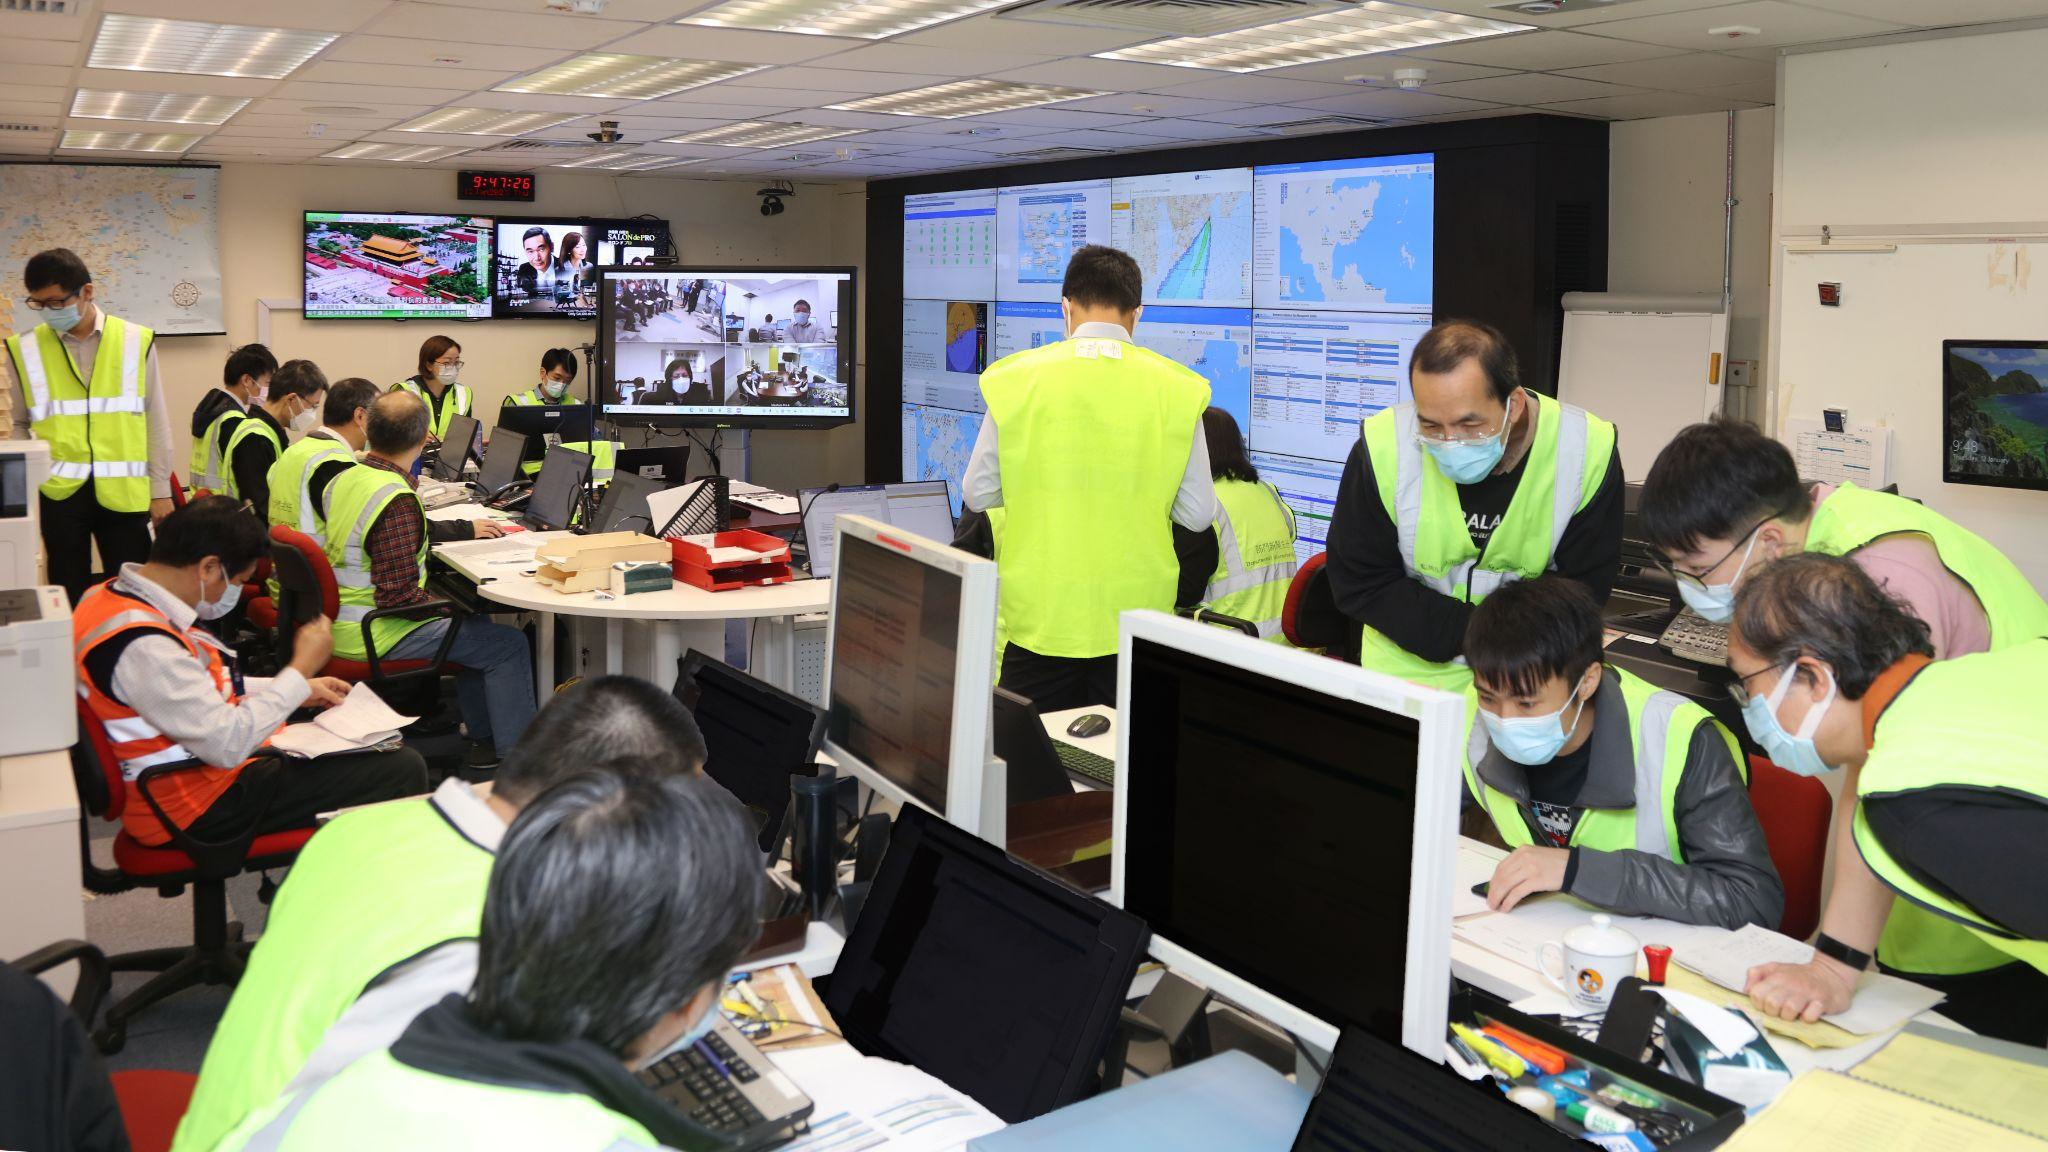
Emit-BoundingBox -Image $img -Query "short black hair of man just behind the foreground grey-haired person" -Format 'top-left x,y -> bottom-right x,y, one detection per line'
492,676 -> 709,804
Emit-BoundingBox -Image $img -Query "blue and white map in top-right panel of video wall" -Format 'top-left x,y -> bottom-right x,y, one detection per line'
1260,172 -> 1436,312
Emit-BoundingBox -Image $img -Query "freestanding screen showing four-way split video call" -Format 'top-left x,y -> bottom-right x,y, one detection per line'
598,266 -> 854,428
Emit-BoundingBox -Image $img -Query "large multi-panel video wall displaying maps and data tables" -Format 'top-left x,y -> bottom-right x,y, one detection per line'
901,154 -> 1436,532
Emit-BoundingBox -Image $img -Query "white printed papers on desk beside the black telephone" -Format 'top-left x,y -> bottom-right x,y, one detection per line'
772,1043 -> 1004,1152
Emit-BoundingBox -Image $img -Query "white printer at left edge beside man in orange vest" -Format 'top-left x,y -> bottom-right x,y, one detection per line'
0,584 -> 78,756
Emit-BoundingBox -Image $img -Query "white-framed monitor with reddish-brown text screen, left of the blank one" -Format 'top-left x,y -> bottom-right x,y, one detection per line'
825,517 -> 1008,845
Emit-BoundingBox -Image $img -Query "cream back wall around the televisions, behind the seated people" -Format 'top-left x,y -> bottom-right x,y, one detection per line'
12,164 -> 866,490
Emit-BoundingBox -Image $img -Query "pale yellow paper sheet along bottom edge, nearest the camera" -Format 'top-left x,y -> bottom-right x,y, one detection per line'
1720,1072 -> 2042,1152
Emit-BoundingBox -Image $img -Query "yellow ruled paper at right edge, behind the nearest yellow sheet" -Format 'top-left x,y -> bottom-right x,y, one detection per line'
1853,1025 -> 2048,1140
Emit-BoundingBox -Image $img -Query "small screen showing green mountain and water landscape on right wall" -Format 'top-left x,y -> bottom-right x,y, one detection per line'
1942,340 -> 2048,490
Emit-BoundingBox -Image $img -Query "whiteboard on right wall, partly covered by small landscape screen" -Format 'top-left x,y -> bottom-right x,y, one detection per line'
1772,242 -> 2048,588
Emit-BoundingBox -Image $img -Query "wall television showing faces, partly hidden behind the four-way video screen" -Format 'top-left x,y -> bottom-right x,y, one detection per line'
492,217 -> 670,320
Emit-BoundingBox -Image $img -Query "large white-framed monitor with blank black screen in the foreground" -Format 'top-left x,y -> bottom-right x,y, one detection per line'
1110,613 -> 1464,1060
